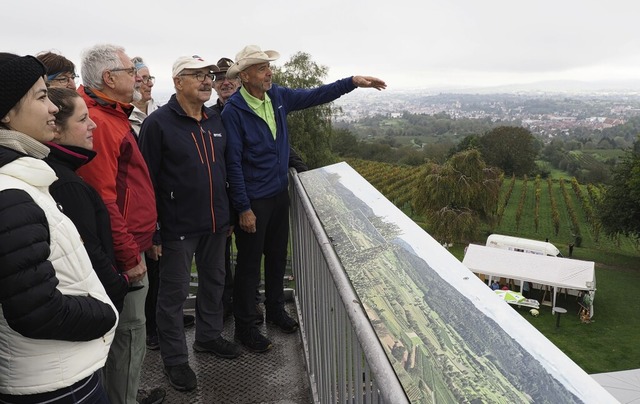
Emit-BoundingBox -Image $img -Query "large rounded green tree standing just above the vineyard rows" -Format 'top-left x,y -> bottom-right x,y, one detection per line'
480,126 -> 539,176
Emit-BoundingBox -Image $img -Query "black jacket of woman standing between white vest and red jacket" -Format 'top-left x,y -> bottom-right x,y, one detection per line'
44,143 -> 129,312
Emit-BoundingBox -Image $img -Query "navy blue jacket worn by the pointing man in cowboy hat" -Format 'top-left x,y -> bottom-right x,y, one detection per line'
222,77 -> 356,213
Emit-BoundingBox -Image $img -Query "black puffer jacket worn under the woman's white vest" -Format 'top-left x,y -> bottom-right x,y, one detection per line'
0,146 -> 116,341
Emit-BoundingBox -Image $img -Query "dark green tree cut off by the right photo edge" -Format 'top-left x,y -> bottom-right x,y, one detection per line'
598,140 -> 640,238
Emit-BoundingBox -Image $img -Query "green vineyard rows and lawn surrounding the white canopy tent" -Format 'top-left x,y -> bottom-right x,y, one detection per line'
347,160 -> 640,373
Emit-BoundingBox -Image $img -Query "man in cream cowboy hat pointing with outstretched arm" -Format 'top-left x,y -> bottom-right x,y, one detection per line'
222,45 -> 386,352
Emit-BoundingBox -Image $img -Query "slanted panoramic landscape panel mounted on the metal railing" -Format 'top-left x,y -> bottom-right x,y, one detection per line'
299,163 -> 616,403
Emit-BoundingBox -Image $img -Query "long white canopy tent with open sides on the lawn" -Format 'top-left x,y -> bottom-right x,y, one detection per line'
462,244 -> 596,316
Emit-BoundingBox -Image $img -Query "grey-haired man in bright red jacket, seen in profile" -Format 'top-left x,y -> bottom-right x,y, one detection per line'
78,45 -> 164,404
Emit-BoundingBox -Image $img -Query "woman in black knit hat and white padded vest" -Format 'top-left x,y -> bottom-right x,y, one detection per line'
0,53 -> 117,403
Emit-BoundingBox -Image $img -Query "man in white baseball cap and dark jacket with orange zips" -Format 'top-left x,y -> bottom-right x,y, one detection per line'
140,56 -> 241,391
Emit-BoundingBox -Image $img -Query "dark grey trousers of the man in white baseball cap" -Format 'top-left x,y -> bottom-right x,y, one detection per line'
156,234 -> 227,366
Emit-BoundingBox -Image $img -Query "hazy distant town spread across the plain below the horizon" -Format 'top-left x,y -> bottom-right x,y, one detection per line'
334,91 -> 640,137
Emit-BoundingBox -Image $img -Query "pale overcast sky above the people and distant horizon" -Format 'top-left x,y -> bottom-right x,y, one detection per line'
5,0 -> 640,91
